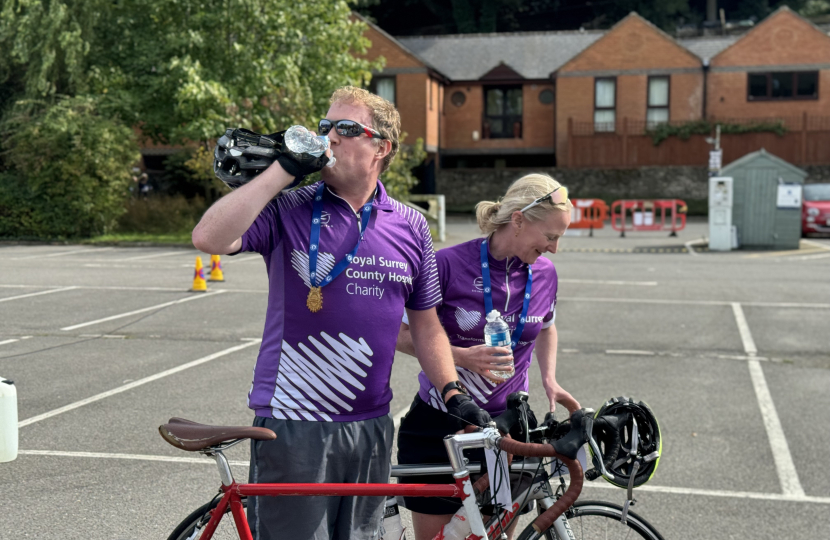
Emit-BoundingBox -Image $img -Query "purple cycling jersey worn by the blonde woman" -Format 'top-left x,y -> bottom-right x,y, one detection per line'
418,238 -> 558,416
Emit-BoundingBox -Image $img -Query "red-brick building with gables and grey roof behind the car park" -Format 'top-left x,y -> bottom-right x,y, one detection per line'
366,8 -> 830,176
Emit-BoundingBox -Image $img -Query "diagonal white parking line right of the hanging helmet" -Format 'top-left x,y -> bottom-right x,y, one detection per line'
732,302 -> 804,497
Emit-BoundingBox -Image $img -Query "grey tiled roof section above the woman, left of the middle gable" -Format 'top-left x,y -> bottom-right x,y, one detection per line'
396,30 -> 605,81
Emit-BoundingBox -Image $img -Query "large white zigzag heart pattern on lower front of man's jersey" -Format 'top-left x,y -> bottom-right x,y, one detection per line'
271,332 -> 373,422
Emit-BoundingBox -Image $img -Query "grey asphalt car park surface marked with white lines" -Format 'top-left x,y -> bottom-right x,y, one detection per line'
0,218 -> 830,540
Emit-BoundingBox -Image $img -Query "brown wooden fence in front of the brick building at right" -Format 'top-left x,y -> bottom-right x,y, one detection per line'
563,113 -> 830,168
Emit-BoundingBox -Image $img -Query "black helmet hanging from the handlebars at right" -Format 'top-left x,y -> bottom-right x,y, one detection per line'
589,397 -> 663,488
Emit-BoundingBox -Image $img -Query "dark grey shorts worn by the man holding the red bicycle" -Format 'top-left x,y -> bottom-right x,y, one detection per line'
248,415 -> 394,540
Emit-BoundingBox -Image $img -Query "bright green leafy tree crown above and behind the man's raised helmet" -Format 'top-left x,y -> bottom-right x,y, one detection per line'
90,0 -> 379,144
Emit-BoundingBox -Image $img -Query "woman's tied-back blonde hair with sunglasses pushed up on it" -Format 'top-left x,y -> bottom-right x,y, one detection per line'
476,173 -> 573,234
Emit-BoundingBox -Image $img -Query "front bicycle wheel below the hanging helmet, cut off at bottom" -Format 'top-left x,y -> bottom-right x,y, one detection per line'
519,501 -> 663,540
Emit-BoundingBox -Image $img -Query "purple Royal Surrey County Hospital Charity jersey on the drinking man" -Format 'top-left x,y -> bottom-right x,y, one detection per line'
241,181 -> 441,421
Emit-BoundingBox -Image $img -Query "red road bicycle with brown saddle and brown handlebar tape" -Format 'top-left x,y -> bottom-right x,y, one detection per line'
159,393 -> 663,540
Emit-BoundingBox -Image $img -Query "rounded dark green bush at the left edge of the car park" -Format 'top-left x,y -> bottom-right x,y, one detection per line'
0,97 -> 140,238
